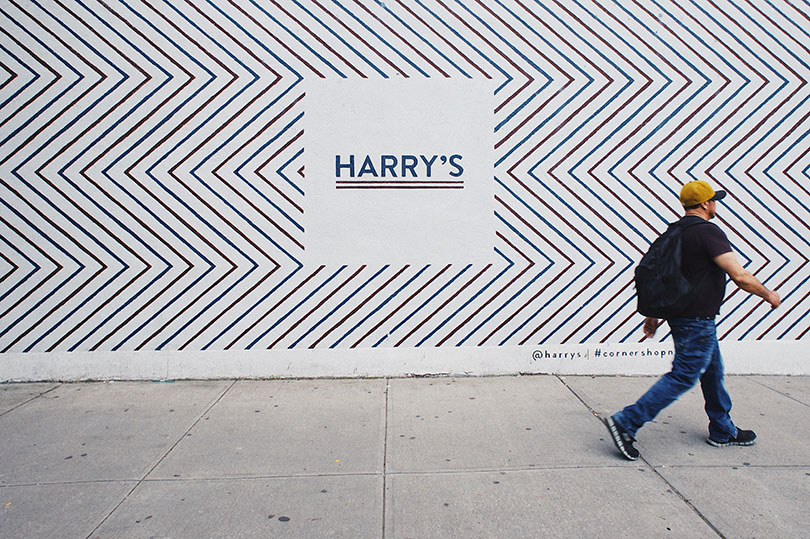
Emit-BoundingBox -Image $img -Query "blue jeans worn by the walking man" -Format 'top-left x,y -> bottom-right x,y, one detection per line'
613,318 -> 737,442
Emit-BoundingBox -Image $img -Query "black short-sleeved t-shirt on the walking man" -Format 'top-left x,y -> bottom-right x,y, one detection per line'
680,215 -> 731,317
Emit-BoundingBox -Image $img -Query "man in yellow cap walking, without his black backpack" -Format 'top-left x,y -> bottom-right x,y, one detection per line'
605,181 -> 781,460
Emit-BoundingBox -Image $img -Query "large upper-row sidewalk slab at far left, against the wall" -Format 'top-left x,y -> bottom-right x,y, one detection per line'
0,382 -> 231,485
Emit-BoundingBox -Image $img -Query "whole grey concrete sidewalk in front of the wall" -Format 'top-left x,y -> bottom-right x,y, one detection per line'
0,376 -> 810,538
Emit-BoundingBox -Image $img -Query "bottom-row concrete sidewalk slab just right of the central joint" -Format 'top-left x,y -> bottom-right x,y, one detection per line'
385,467 -> 717,539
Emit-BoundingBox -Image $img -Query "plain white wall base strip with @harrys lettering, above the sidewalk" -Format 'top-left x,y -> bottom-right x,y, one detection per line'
0,341 -> 810,382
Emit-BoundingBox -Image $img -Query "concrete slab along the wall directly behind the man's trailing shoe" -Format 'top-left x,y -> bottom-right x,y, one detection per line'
387,376 -> 623,472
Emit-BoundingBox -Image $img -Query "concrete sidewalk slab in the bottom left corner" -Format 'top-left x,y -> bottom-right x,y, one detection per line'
0,481 -> 135,537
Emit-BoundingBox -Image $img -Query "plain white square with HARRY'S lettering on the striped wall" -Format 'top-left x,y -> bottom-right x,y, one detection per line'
303,79 -> 497,265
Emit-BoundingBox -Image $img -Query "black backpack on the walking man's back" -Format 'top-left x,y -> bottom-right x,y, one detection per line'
635,220 -> 707,318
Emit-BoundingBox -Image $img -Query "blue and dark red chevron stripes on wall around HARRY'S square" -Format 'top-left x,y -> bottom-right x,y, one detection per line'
0,0 -> 810,353
